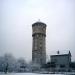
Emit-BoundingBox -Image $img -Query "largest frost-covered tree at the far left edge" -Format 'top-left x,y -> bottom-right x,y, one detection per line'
0,54 -> 16,72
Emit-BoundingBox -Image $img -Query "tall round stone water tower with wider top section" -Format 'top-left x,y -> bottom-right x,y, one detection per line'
32,21 -> 46,65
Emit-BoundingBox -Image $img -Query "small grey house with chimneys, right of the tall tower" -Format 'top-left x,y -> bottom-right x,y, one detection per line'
51,51 -> 71,71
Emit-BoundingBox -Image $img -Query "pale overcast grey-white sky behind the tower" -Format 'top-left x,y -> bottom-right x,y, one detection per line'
0,0 -> 75,60
